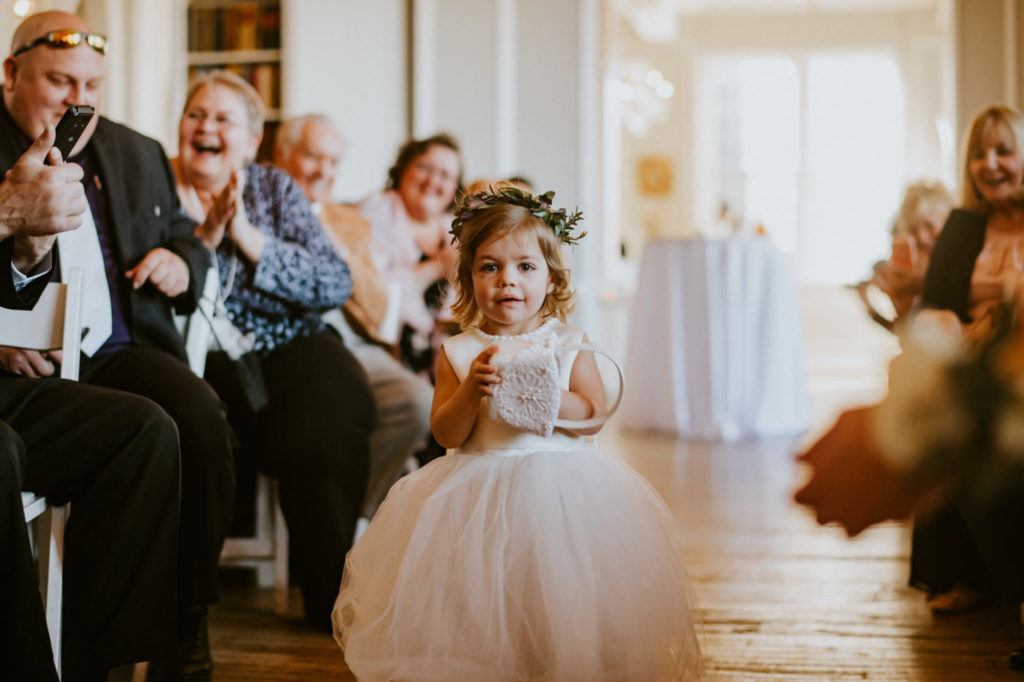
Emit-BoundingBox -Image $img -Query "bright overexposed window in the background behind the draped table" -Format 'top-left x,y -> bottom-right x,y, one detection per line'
693,52 -> 906,283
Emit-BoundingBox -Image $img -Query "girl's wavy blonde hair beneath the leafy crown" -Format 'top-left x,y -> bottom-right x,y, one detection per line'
452,204 -> 575,329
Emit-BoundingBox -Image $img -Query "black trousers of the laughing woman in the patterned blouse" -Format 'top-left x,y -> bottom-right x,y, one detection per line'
204,331 -> 377,630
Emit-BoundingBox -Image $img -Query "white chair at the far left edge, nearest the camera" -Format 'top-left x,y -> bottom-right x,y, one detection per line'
0,267 -> 82,675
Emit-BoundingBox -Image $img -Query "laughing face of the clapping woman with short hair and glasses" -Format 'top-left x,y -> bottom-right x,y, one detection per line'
178,83 -> 259,190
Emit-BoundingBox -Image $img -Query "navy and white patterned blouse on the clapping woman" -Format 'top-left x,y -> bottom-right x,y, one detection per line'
216,164 -> 352,355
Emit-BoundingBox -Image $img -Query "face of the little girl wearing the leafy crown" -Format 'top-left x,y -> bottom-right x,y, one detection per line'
473,229 -> 554,335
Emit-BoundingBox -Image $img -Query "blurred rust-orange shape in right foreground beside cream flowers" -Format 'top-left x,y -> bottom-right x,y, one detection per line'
795,408 -> 925,538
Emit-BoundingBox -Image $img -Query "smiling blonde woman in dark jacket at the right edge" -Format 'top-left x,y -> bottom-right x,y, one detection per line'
910,106 -> 1024,612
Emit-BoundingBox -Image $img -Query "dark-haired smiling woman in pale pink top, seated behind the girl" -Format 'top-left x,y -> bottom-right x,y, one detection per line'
358,134 -> 462,375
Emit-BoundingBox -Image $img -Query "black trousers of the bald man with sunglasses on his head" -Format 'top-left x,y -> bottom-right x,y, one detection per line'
81,346 -> 234,607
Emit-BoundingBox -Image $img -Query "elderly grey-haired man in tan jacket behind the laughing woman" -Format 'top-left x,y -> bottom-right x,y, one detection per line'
273,115 -> 433,518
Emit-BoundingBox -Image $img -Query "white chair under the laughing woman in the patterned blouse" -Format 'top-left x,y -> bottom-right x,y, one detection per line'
178,260 -> 288,615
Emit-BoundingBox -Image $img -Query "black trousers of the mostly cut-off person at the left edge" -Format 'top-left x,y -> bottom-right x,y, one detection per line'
0,372 -> 178,682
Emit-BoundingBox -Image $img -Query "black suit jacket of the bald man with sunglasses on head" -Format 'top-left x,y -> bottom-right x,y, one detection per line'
0,108 -> 210,359
